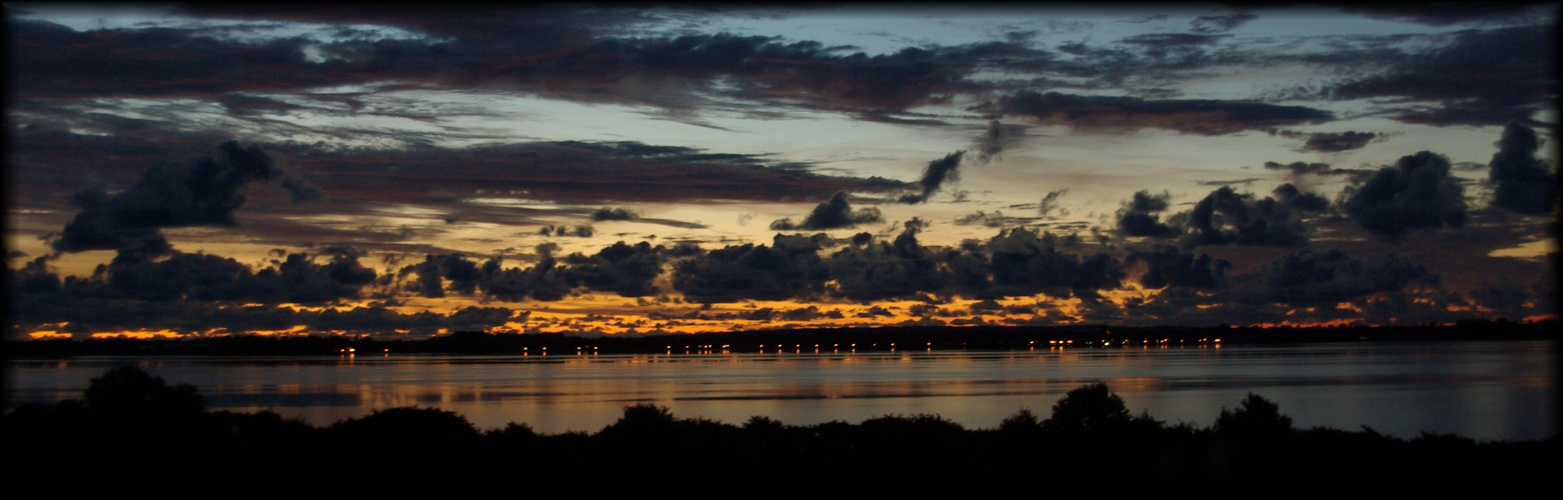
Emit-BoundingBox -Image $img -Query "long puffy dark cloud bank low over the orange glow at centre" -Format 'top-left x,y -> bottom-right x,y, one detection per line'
674,223 -> 1124,303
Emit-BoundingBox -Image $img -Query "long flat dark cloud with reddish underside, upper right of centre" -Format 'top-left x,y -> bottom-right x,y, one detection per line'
985,91 -> 1335,136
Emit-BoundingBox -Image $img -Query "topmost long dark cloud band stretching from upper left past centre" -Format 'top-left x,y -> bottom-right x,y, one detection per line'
42,6 -> 1047,116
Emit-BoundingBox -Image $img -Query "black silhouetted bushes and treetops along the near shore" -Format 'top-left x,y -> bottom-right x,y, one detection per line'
0,367 -> 1560,492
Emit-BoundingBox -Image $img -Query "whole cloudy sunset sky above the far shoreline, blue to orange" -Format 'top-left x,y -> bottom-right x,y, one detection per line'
5,3 -> 1558,339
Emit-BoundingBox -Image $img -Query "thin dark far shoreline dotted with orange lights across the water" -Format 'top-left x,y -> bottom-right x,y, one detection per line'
6,319 -> 1560,358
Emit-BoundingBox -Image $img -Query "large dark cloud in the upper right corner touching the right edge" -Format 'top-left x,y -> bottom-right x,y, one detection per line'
1325,23 -> 1557,127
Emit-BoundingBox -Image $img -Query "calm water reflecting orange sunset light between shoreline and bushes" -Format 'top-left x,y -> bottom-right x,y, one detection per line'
6,342 -> 1558,439
